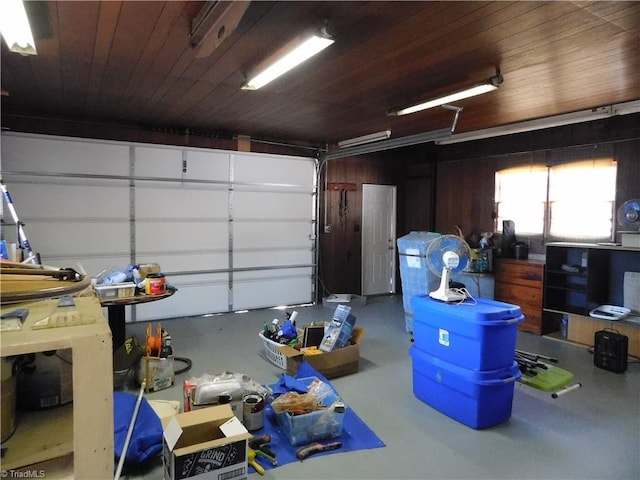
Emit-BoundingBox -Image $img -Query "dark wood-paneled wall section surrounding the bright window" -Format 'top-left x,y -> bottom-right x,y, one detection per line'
435,114 -> 640,253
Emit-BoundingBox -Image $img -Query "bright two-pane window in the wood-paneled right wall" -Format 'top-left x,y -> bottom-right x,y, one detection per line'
495,158 -> 617,242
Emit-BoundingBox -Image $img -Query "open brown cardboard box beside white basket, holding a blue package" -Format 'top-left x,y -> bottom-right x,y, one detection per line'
278,326 -> 365,378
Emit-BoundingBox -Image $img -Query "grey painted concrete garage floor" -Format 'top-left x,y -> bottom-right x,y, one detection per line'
122,296 -> 640,480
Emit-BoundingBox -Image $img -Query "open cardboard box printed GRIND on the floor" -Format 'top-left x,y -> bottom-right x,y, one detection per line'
162,405 -> 251,480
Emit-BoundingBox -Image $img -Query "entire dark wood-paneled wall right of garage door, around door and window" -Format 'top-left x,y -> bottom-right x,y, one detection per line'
320,114 -> 640,293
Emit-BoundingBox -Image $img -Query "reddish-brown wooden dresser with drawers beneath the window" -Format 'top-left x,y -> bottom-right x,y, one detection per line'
494,258 -> 553,335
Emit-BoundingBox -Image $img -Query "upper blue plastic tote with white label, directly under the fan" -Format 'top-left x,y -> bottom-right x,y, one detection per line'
412,295 -> 524,370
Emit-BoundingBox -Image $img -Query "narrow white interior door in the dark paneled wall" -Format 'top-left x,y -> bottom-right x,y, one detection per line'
362,185 -> 396,295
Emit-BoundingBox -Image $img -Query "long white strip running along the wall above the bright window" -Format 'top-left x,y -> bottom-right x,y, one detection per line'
436,100 -> 640,145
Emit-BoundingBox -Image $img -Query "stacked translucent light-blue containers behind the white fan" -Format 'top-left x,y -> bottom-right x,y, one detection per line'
397,232 -> 441,333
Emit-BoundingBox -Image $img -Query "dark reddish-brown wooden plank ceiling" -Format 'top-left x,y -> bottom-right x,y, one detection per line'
1,0 -> 640,145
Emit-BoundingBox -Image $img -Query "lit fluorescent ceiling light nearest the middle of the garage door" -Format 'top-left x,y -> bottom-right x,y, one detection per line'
242,30 -> 334,90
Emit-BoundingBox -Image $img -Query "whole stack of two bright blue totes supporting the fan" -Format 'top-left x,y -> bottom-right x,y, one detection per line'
410,295 -> 524,429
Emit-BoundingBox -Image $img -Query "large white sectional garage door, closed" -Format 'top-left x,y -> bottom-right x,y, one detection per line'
1,133 -> 317,320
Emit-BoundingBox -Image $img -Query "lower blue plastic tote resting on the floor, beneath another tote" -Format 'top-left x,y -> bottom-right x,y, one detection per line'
410,346 -> 522,429
